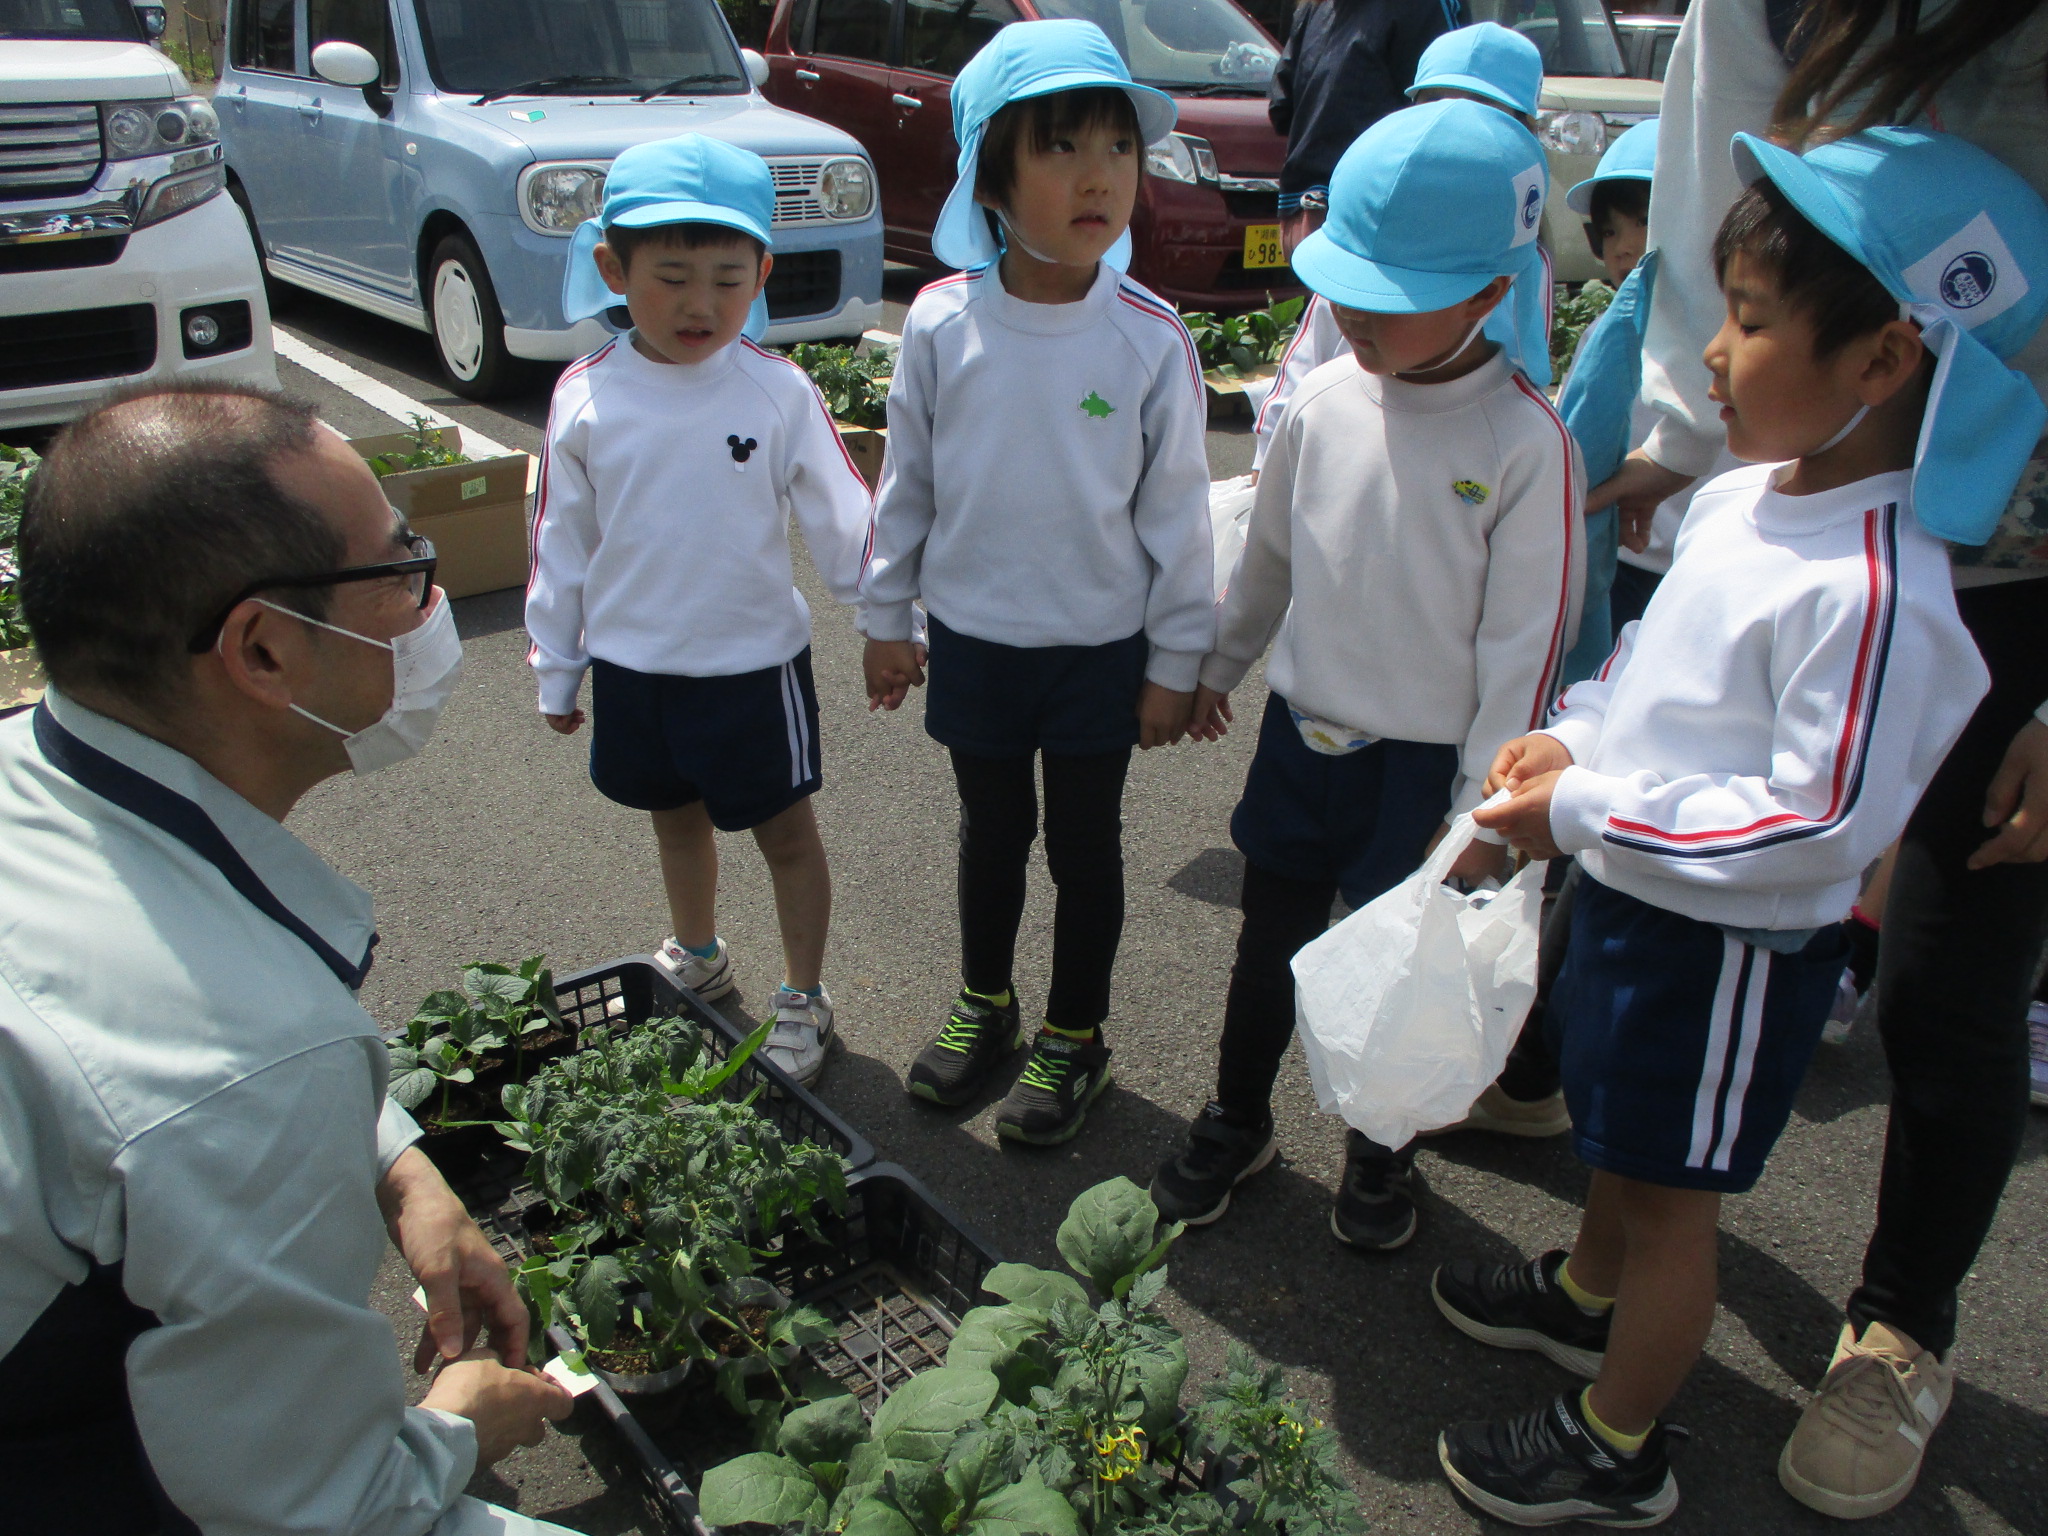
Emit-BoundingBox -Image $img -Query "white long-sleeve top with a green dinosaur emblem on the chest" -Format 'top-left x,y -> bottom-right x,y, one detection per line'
862,262 -> 1214,692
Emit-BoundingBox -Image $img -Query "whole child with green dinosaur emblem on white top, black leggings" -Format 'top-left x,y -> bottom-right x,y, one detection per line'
862,20 -> 1214,1145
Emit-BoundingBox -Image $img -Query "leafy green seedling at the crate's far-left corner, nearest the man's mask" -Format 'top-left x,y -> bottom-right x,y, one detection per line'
385,954 -> 567,1122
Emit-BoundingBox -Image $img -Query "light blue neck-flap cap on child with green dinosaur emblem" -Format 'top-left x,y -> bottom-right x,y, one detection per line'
932,20 -> 1180,270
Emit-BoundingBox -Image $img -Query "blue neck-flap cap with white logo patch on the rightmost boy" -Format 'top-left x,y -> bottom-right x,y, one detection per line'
1731,127 -> 2048,545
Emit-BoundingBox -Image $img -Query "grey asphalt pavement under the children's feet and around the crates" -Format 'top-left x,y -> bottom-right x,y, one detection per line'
279,272 -> 2048,1536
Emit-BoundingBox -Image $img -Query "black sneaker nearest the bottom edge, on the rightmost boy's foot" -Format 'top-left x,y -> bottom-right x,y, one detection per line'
1436,1393 -> 1690,1528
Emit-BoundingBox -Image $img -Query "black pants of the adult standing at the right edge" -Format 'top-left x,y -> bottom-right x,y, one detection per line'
1849,582 -> 2048,1352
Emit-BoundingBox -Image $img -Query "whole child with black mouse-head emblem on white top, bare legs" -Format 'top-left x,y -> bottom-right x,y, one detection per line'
526,133 -> 872,1081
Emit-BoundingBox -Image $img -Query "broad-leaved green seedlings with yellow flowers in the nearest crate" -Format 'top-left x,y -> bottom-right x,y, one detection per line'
700,1180 -> 1362,1536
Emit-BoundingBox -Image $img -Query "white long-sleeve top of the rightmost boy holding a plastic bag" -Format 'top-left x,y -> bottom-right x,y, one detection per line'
1546,465 -> 1989,930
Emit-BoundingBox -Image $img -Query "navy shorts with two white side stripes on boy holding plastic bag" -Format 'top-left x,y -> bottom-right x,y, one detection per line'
1544,870 -> 1849,1194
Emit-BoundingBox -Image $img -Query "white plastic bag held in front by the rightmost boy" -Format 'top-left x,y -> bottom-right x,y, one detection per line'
1294,815 -> 1544,1147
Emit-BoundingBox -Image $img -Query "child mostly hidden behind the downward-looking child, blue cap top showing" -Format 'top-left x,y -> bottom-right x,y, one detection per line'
1251,20 -> 1550,475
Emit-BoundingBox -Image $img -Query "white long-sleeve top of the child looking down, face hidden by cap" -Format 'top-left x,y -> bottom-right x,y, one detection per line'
1202,342 -> 1585,811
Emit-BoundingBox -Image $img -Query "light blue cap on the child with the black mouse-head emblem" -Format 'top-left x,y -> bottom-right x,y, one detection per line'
561,133 -> 774,342
